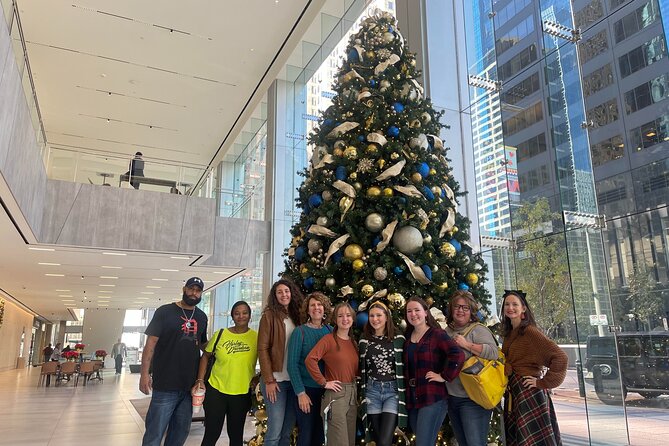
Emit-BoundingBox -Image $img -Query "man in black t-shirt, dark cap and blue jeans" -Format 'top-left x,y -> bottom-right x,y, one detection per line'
139,277 -> 207,446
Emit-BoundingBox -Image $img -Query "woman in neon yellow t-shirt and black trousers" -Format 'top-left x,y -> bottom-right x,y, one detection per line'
193,301 -> 258,446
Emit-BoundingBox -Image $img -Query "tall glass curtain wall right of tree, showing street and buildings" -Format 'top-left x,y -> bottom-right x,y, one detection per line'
463,0 -> 669,444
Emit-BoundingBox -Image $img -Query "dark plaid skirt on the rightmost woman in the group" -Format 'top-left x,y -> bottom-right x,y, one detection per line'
504,374 -> 562,446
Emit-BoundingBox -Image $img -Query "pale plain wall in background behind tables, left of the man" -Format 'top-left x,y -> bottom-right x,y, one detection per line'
81,308 -> 125,355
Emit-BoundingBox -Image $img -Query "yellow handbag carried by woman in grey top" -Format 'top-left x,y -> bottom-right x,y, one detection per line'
459,324 -> 509,409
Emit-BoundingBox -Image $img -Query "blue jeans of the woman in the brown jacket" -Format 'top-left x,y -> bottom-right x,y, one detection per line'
260,381 -> 297,446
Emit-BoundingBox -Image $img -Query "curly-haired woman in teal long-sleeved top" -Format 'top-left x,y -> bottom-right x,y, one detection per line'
288,292 -> 332,446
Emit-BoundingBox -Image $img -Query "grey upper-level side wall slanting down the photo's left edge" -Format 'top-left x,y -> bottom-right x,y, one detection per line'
0,8 -> 46,239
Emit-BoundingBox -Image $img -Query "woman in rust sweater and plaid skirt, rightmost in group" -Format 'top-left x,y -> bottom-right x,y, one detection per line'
502,290 -> 567,446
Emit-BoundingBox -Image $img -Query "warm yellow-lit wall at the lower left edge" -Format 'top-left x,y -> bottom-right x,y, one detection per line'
0,294 -> 33,372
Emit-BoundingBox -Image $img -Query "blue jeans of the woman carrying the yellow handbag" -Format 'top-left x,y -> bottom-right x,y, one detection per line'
448,396 -> 492,446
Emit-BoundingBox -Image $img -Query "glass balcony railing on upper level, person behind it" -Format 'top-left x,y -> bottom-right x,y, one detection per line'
46,146 -> 207,195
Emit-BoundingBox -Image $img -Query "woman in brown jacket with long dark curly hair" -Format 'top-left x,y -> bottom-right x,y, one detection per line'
258,279 -> 302,446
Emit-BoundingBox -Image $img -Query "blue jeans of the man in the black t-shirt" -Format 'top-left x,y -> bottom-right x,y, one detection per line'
142,390 -> 193,446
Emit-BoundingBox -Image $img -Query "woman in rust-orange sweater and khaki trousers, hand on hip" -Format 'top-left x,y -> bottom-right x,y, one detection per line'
304,302 -> 358,446
